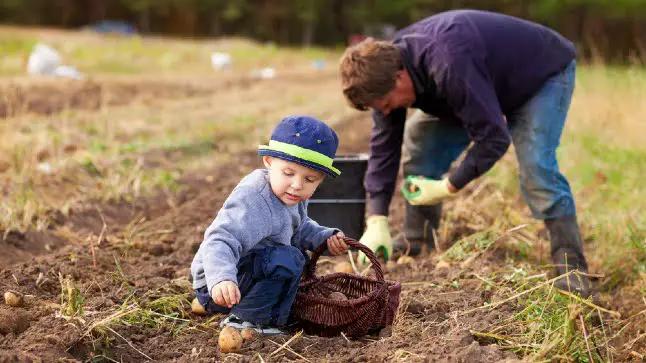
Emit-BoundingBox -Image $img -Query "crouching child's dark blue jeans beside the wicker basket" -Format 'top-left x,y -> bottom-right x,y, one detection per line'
195,246 -> 306,326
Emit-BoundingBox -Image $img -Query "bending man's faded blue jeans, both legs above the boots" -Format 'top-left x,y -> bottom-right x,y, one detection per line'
402,61 -> 576,220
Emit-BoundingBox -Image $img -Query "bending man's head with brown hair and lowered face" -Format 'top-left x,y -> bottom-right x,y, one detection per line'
339,38 -> 415,115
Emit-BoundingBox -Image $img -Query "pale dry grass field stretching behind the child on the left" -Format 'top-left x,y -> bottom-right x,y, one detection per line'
0,34 -> 349,233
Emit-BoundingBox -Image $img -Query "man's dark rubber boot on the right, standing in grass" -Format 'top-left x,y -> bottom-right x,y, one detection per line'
545,216 -> 591,297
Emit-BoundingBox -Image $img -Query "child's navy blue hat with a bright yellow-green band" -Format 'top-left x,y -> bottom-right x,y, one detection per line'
258,116 -> 341,178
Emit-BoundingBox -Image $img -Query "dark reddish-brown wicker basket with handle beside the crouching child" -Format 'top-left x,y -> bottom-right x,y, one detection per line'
292,238 -> 401,337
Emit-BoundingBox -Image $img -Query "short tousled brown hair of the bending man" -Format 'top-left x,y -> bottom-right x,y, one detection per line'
339,38 -> 403,111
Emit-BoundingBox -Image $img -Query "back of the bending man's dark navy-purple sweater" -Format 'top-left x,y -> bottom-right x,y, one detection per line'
400,10 -> 576,112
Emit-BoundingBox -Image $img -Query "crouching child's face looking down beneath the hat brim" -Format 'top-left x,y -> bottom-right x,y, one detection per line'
262,156 -> 325,206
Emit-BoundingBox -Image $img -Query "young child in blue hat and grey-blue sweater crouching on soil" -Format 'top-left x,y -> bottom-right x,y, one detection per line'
191,116 -> 348,334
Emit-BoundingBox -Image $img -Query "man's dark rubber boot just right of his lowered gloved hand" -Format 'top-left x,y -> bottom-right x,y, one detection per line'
393,202 -> 442,256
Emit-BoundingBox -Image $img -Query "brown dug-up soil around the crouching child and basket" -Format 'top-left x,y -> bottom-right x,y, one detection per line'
0,78 -> 637,362
